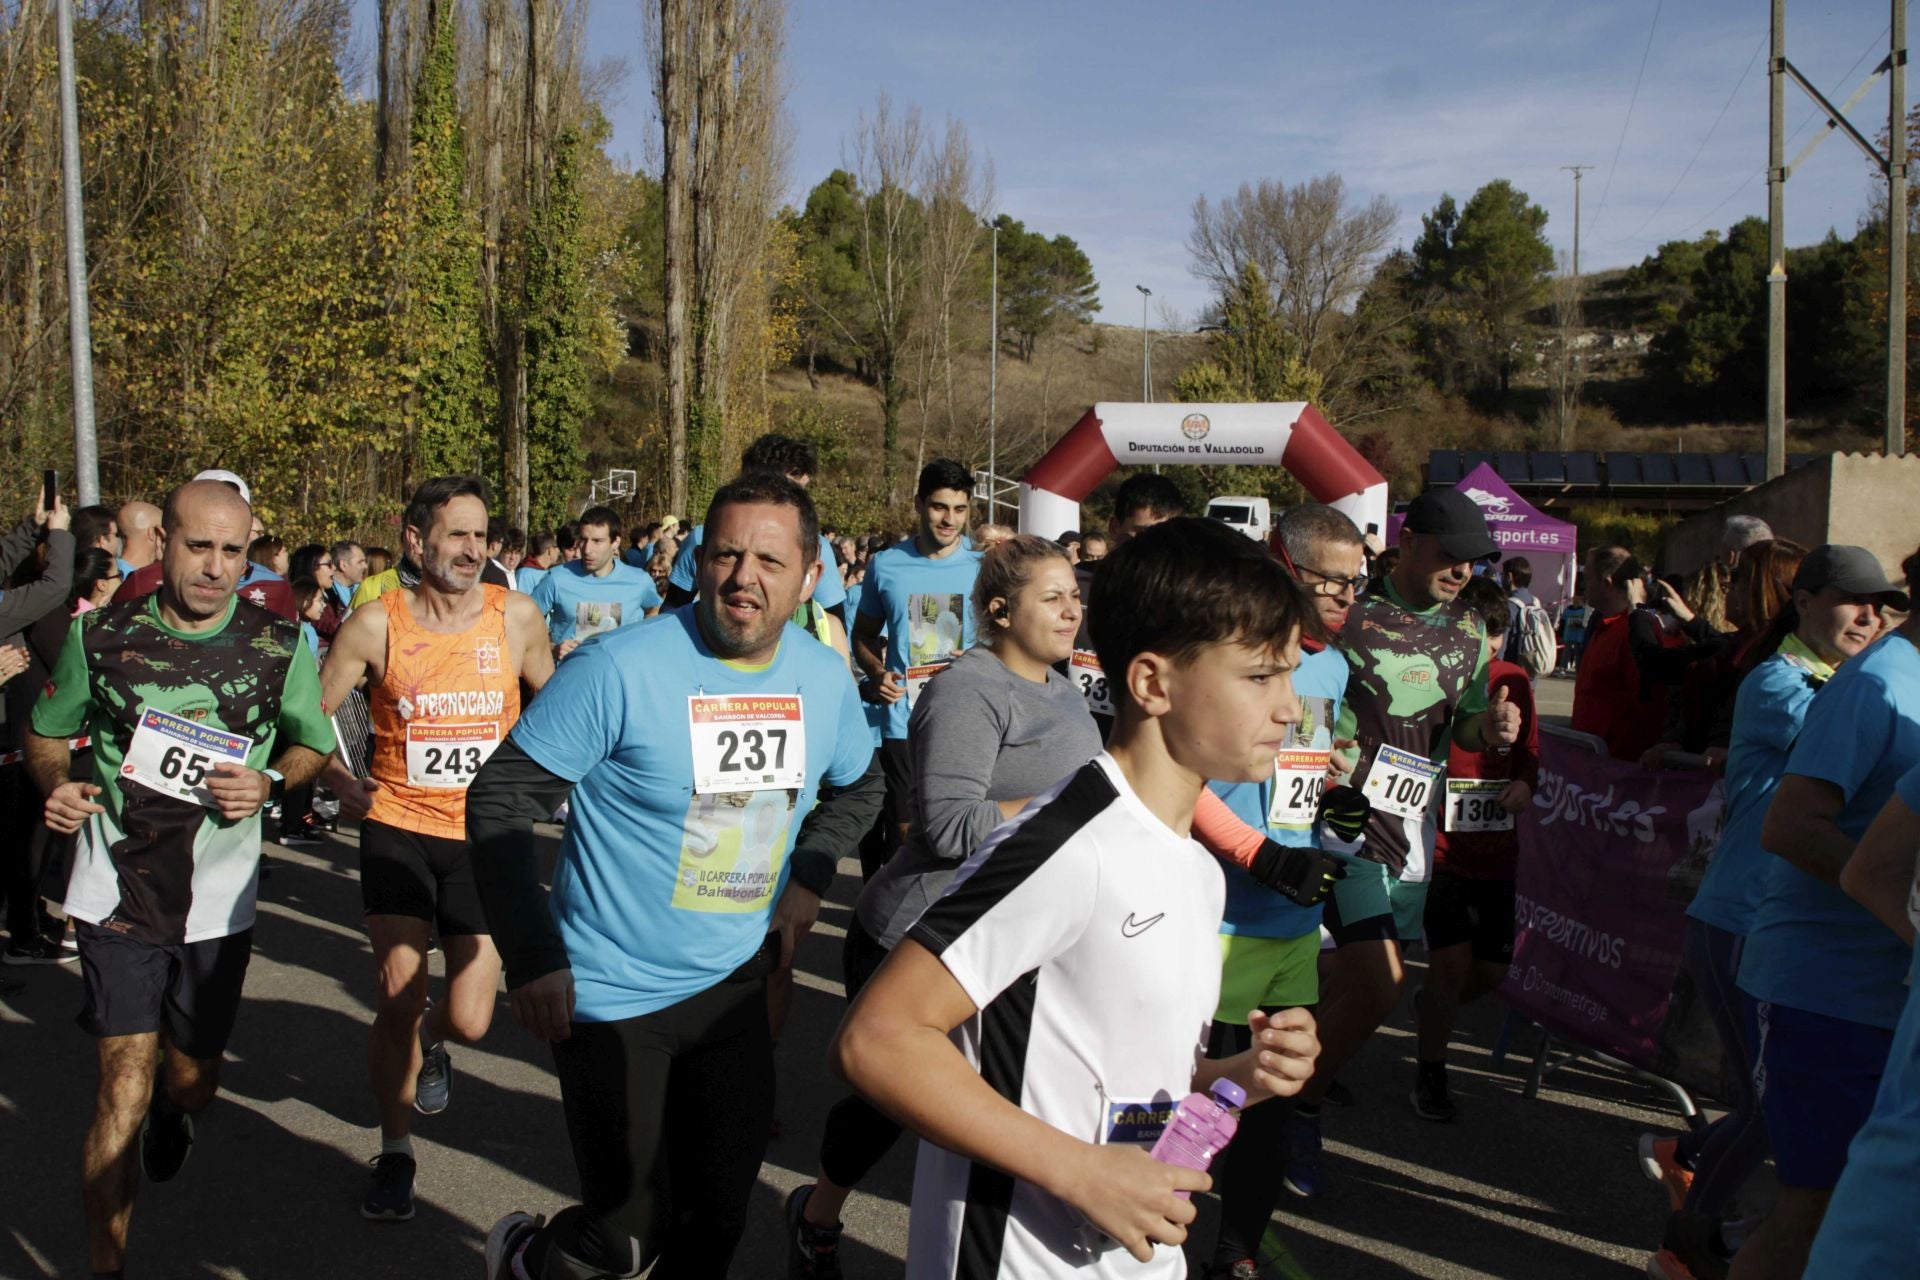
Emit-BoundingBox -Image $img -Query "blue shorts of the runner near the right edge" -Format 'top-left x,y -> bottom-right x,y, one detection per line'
1741,992 -> 1893,1192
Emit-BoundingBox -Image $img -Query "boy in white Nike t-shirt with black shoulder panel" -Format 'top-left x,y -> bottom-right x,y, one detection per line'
831,520 -> 1315,1280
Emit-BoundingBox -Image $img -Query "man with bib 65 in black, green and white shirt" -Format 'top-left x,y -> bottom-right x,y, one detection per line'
27,482 -> 334,1276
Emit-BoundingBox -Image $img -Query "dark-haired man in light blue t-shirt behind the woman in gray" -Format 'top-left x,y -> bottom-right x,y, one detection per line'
852,459 -> 979,846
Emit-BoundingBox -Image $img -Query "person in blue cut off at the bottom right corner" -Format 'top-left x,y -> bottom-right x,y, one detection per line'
1807,756 -> 1920,1280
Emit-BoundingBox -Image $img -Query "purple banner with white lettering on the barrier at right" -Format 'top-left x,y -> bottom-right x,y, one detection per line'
1501,733 -> 1722,1075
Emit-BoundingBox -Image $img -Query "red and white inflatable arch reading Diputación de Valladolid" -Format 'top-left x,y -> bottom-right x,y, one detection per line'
1020,401 -> 1386,537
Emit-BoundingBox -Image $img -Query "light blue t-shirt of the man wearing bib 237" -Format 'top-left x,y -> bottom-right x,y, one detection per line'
513,608 -> 874,1023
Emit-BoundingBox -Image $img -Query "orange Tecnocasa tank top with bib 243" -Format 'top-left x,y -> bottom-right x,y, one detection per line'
367,583 -> 520,841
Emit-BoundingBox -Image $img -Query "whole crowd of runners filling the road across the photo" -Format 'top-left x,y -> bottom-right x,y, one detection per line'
0,436 -> 1920,1280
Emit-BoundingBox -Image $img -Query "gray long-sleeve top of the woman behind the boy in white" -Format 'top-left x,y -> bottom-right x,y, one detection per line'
856,649 -> 1100,950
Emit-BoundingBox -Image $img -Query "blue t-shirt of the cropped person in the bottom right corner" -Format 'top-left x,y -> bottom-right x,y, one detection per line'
1805,766 -> 1920,1280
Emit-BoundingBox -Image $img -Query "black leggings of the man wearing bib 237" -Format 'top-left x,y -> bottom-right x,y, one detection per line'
526,948 -> 780,1280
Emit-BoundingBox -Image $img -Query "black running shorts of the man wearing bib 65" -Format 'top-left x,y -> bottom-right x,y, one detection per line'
73,919 -> 253,1061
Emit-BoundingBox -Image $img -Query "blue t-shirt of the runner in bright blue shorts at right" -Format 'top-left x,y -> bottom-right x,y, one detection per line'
1740,635 -> 1920,1031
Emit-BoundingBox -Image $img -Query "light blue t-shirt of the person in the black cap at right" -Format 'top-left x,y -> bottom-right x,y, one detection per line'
1686,652 -> 1820,936
